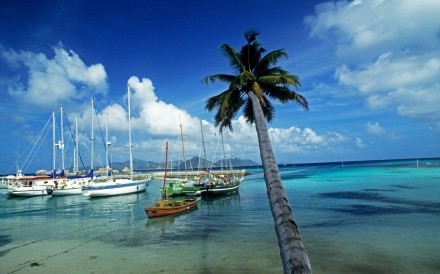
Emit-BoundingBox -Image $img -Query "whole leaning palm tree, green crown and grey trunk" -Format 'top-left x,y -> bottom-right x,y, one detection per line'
203,30 -> 312,273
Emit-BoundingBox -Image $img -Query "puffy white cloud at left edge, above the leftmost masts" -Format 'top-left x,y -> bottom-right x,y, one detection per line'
0,46 -> 108,109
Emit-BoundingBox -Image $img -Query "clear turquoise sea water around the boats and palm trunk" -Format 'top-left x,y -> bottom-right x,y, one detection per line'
0,159 -> 440,274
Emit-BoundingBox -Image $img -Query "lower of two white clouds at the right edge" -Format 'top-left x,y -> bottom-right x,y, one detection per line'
336,52 -> 440,122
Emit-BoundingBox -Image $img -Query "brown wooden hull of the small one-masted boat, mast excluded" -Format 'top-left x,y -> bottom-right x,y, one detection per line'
145,199 -> 198,218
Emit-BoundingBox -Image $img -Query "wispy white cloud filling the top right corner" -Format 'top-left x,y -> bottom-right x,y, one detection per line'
305,0 -> 440,60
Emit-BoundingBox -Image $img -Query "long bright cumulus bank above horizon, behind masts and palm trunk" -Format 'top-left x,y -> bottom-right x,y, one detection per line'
87,76 -> 347,161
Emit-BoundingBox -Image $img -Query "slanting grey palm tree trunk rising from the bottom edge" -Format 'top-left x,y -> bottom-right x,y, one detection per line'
248,92 -> 312,273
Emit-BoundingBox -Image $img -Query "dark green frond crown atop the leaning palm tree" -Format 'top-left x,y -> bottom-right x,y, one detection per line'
203,31 -> 309,131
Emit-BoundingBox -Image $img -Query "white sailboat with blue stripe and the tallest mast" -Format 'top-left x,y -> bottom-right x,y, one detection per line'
82,86 -> 151,198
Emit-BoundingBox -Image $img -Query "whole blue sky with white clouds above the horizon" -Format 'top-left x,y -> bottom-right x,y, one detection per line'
0,0 -> 440,172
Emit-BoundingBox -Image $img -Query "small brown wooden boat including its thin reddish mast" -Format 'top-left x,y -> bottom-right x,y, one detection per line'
145,142 -> 198,218
